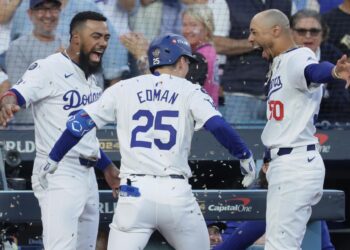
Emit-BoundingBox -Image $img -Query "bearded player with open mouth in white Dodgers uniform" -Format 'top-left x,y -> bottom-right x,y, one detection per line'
0,12 -> 119,250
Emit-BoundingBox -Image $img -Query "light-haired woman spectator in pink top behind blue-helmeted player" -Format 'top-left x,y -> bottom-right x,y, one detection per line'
182,4 -> 219,106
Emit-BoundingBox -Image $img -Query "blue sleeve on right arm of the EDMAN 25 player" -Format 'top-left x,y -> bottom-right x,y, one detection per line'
204,116 -> 251,159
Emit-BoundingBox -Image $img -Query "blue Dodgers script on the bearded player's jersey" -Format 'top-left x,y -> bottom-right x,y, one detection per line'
63,90 -> 101,110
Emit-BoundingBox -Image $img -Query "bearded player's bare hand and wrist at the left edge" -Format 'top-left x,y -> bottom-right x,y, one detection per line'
0,90 -> 20,127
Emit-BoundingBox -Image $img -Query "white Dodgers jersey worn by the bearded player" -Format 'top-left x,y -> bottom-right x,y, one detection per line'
13,53 -> 102,157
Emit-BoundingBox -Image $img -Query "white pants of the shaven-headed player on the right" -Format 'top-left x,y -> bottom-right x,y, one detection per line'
265,146 -> 325,250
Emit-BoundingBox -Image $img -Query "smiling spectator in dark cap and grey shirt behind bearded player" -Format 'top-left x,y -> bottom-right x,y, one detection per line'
6,0 -> 63,124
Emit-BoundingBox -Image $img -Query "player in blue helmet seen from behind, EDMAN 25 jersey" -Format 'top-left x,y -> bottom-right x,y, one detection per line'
41,34 -> 255,250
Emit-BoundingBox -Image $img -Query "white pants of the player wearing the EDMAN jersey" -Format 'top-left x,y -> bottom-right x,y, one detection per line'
108,175 -> 210,250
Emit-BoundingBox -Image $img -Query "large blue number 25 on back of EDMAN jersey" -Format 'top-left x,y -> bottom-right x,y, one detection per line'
130,109 -> 179,150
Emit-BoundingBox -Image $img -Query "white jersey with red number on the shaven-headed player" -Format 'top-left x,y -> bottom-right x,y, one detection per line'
261,48 -> 322,148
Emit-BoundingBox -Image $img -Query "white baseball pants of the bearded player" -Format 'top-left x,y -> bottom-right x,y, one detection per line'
32,157 -> 99,250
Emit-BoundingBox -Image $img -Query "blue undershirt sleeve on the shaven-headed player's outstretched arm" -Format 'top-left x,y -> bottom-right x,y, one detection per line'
304,62 -> 334,84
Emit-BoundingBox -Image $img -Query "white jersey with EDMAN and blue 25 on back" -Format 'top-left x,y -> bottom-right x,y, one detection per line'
85,74 -> 220,177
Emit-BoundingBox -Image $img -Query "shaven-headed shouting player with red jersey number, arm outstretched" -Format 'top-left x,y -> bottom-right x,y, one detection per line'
249,9 -> 350,250
